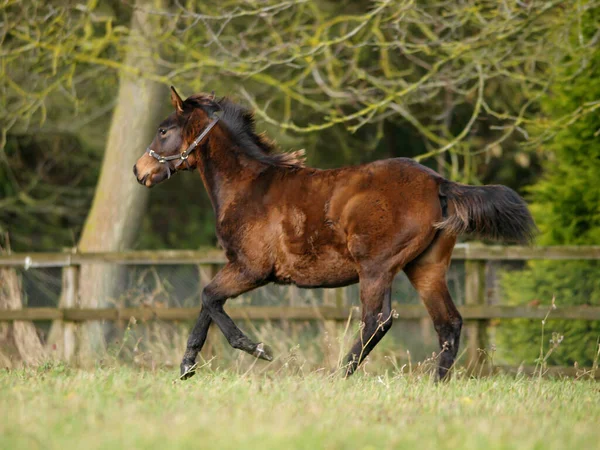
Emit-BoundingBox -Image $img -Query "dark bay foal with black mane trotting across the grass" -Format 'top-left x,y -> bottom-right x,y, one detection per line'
133,88 -> 535,378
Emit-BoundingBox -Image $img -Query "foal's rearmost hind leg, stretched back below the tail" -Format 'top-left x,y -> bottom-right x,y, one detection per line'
404,232 -> 462,379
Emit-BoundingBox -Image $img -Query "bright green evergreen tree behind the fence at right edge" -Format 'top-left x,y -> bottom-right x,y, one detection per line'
498,8 -> 600,366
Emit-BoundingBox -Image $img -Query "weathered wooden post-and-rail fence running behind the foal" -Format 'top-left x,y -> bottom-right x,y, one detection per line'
0,243 -> 600,370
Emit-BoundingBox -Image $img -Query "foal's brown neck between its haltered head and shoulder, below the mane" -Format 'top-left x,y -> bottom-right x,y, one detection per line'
197,126 -> 268,222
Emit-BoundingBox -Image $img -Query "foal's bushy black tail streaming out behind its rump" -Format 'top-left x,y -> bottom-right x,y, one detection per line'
436,180 -> 537,244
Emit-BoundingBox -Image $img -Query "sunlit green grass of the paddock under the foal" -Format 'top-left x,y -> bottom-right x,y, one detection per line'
0,365 -> 600,449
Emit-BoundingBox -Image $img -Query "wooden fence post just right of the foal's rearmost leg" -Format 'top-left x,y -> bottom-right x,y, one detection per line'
465,259 -> 487,369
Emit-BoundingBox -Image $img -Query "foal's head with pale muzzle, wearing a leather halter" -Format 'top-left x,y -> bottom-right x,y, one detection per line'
133,86 -> 221,187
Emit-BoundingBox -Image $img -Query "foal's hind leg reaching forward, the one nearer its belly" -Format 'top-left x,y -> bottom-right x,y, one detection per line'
346,274 -> 393,376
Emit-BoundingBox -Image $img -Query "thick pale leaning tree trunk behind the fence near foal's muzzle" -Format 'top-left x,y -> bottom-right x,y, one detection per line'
78,0 -> 166,353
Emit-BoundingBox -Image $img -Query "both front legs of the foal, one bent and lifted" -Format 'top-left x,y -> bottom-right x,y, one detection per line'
181,263 -> 273,378
